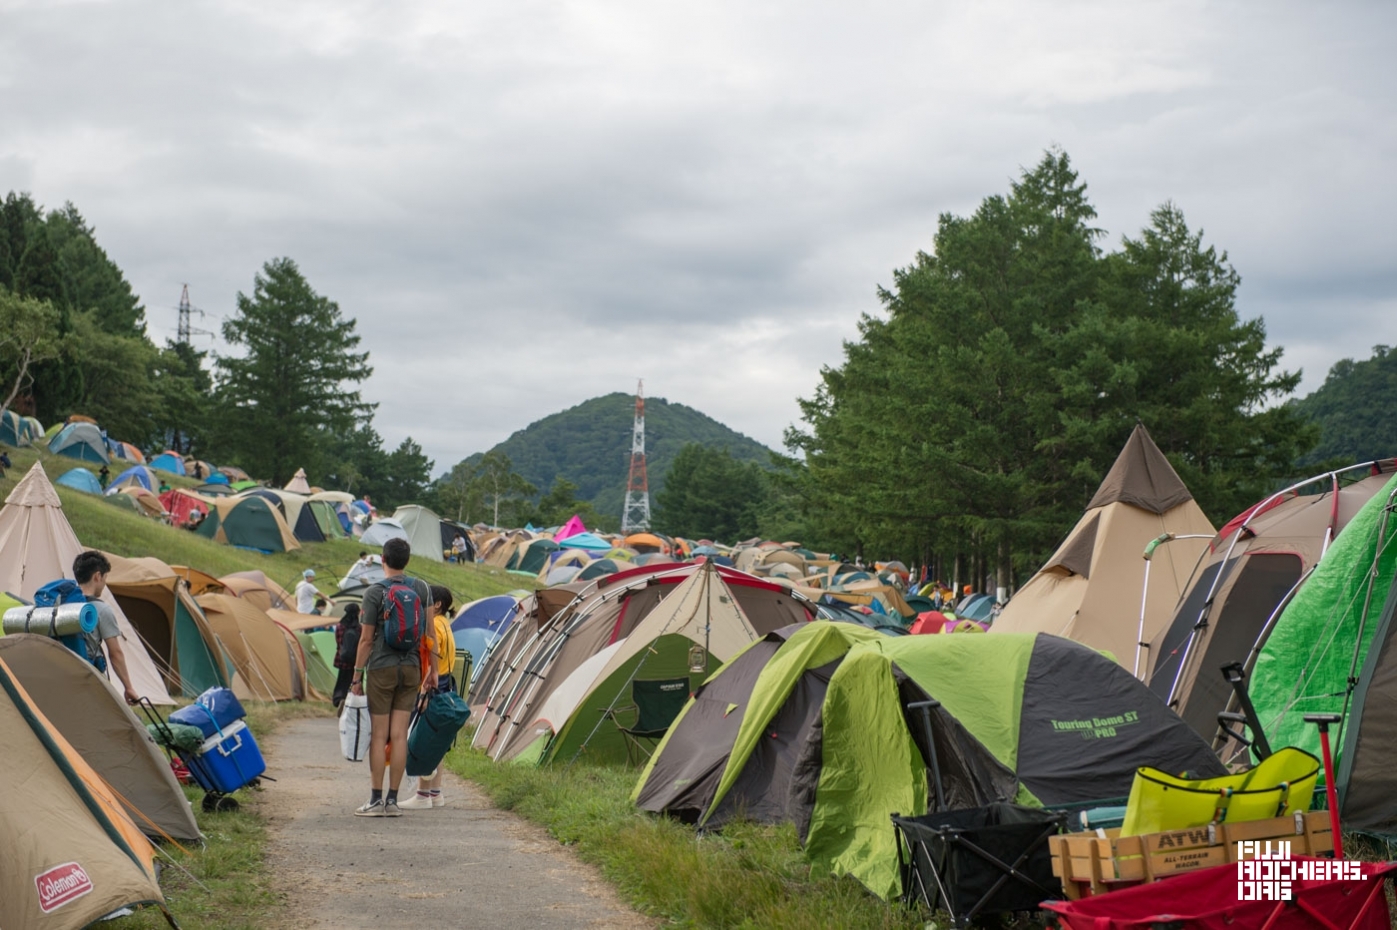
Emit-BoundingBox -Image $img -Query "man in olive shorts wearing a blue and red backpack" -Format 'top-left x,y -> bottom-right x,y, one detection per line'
349,539 -> 437,817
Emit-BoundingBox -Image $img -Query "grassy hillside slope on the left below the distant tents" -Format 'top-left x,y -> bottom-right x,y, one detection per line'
0,448 -> 527,603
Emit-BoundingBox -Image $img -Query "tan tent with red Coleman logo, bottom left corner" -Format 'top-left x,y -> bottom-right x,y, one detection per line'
0,658 -> 165,930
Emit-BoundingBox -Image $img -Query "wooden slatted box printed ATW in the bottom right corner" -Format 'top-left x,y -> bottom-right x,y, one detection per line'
1048,810 -> 1334,899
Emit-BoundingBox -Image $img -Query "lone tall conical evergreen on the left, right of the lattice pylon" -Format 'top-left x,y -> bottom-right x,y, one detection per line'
218,258 -> 374,486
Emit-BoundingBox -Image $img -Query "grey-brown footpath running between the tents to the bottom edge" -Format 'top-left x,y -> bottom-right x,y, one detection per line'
258,718 -> 655,930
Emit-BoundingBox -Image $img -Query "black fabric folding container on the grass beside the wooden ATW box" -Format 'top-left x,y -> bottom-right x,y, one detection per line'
893,802 -> 1066,927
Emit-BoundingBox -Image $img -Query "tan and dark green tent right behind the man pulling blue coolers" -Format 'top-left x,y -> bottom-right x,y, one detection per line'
106,553 -> 228,697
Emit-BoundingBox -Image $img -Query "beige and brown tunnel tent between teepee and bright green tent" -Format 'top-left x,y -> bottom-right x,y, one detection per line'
1150,459 -> 1394,739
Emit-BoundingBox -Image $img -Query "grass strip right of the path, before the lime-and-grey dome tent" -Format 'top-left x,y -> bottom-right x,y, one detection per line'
447,740 -> 926,930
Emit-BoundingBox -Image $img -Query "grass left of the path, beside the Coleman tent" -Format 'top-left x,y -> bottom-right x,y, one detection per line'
102,702 -> 330,930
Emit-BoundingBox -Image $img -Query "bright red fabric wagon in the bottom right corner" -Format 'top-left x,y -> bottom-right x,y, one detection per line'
1042,856 -> 1397,930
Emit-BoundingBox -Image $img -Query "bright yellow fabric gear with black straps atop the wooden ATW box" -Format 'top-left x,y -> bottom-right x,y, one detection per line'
1120,746 -> 1320,836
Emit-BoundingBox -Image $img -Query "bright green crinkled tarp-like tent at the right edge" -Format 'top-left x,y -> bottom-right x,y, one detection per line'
1250,476 -> 1397,781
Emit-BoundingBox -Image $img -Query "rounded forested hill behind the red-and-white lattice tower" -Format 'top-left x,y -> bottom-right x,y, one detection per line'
468,394 -> 771,522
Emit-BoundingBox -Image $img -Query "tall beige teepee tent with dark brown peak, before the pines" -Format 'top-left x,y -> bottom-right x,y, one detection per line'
994,423 -> 1214,677
